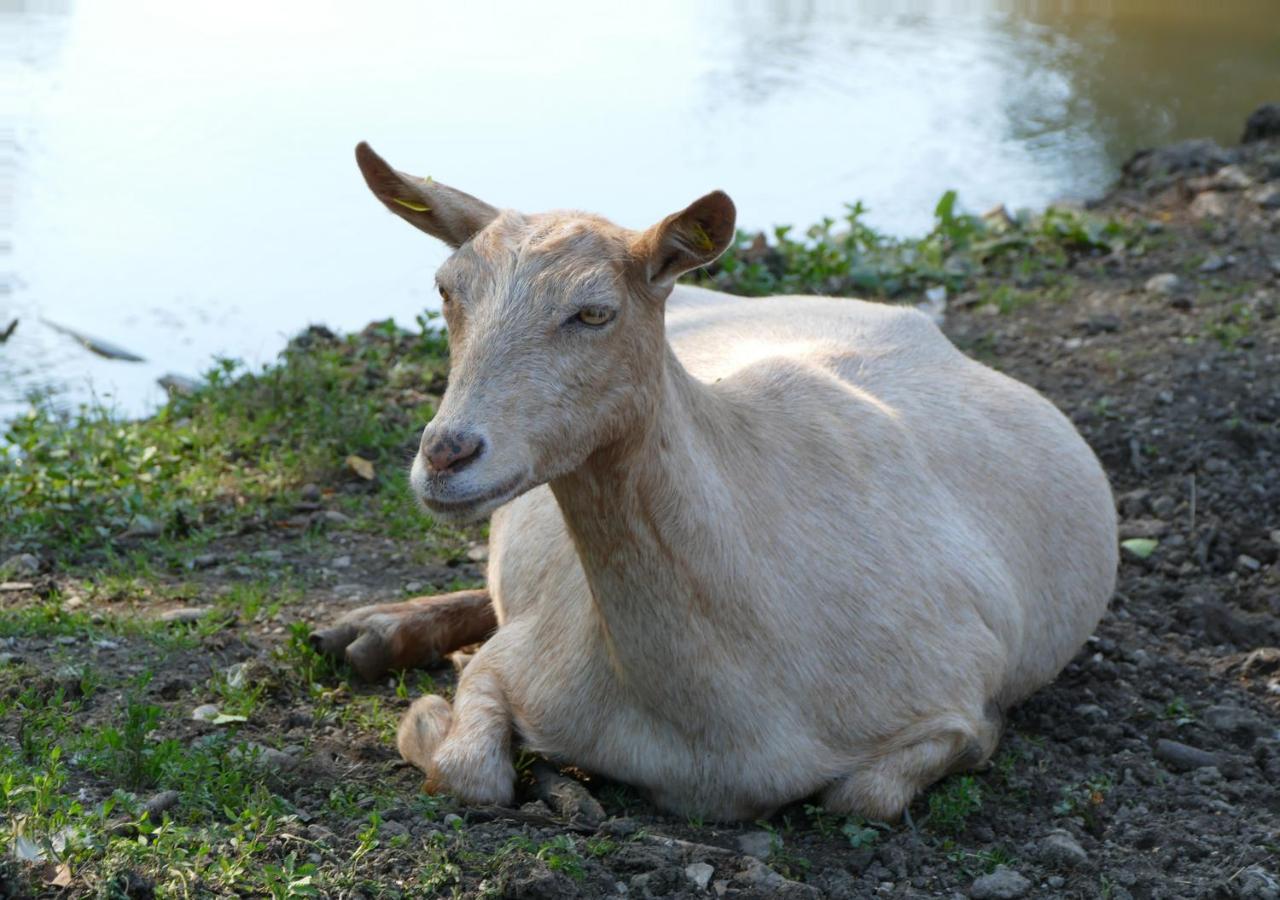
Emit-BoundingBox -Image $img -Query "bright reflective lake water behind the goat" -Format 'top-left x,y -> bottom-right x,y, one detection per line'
0,0 -> 1280,419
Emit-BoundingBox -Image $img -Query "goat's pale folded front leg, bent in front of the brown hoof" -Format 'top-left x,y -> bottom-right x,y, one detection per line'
397,650 -> 516,805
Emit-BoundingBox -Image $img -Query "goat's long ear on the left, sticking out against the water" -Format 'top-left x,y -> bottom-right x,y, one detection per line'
356,141 -> 498,247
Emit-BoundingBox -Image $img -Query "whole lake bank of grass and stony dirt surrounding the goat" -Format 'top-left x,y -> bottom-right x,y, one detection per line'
0,109 -> 1280,897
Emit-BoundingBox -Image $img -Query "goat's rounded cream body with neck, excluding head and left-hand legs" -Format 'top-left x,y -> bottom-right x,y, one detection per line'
476,287 -> 1116,818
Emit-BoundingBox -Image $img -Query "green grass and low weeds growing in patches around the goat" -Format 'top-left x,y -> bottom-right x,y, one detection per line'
0,193 -> 1162,897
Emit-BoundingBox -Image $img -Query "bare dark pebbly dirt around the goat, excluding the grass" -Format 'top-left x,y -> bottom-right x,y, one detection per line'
0,121 -> 1280,899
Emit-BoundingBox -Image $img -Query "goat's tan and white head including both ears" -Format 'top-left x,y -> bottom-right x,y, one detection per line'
356,143 -> 735,521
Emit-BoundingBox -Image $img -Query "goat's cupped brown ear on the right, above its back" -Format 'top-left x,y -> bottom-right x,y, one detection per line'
634,191 -> 737,288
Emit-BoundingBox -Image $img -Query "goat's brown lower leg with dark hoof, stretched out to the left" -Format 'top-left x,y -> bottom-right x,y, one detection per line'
311,590 -> 498,679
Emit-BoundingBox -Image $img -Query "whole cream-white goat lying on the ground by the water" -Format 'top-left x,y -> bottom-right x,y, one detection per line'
314,145 -> 1116,819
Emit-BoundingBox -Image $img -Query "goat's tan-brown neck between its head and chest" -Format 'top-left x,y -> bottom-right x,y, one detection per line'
552,346 -> 755,662
